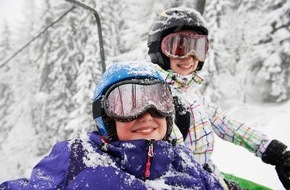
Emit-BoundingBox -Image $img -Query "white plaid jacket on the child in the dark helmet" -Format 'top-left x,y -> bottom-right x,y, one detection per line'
156,65 -> 270,175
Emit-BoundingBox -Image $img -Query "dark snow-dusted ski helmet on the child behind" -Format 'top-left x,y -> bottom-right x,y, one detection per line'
147,7 -> 208,71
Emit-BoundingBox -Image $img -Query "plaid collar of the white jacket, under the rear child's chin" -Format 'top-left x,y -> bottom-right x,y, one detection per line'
156,65 -> 203,88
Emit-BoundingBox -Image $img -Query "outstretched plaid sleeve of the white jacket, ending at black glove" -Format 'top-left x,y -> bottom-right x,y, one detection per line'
203,96 -> 271,157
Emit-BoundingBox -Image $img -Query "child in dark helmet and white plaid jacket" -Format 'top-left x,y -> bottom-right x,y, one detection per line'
148,8 -> 290,189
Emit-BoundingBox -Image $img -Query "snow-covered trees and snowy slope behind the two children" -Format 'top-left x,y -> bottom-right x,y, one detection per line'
0,0 -> 290,190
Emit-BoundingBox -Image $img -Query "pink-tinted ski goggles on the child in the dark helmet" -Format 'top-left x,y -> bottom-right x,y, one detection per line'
161,31 -> 208,61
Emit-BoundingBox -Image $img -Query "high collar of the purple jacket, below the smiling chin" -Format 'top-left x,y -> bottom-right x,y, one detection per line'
89,133 -> 174,180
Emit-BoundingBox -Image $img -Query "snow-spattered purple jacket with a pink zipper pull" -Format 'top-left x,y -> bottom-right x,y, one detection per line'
0,133 -> 222,190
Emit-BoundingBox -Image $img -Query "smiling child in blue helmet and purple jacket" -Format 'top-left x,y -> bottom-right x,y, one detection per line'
0,62 -> 223,190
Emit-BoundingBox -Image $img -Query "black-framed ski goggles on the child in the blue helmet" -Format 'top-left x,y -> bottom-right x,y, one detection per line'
93,79 -> 174,122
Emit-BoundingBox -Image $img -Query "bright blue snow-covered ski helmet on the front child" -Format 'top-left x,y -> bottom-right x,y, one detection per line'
92,61 -> 173,141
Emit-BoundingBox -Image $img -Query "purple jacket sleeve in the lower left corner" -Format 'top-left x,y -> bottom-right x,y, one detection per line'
0,142 -> 69,190
